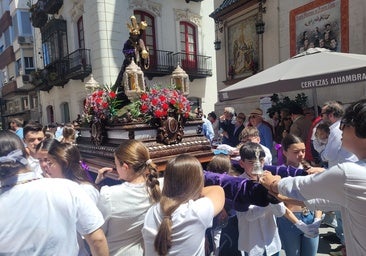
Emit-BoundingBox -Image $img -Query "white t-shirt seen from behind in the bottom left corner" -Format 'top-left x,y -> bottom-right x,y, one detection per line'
0,172 -> 103,256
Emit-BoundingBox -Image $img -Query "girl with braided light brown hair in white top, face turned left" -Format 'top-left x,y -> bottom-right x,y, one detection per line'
96,140 -> 161,256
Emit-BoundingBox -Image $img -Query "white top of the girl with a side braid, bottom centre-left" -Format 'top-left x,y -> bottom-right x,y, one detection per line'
98,182 -> 151,256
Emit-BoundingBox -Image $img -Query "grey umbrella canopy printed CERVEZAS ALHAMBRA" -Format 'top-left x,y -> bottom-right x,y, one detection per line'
219,48 -> 366,101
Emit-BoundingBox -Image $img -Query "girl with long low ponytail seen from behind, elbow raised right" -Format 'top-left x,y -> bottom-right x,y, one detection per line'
142,154 -> 225,255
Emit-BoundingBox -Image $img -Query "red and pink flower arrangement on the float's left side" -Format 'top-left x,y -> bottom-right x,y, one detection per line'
82,85 -> 120,124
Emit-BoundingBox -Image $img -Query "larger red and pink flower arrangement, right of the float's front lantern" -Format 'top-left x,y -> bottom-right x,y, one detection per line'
137,87 -> 191,123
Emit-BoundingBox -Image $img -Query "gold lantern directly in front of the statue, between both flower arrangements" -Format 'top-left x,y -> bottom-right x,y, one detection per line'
123,60 -> 145,101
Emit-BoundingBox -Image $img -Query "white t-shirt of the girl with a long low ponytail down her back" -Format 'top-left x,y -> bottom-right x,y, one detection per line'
142,197 -> 214,256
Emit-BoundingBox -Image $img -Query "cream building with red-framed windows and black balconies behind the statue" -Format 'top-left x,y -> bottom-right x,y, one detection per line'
2,0 -> 217,128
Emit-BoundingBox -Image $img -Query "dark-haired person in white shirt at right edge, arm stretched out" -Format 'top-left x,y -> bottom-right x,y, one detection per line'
261,99 -> 366,255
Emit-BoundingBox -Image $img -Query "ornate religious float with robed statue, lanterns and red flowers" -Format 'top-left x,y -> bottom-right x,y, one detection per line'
77,16 -> 212,179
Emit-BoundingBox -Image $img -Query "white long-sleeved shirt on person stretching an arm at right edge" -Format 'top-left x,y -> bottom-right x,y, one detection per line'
278,159 -> 366,255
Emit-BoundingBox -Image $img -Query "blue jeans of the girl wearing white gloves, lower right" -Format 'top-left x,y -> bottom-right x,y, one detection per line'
277,212 -> 319,256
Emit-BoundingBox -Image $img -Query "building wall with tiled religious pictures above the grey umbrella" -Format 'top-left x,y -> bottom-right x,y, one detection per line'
210,0 -> 366,118
